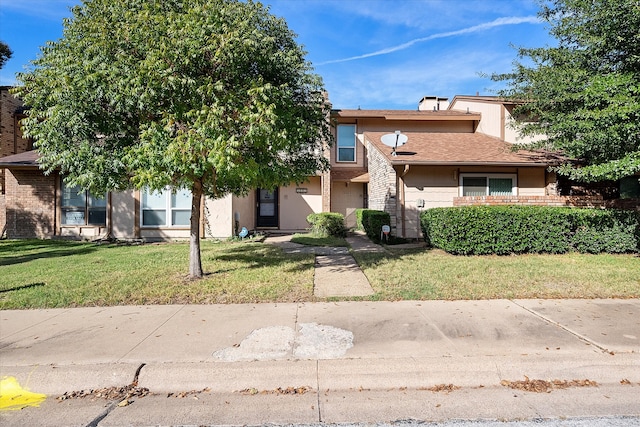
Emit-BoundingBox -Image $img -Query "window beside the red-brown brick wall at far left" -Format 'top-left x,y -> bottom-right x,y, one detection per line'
60,180 -> 107,225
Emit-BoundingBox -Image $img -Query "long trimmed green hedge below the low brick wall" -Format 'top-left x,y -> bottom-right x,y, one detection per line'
420,206 -> 640,255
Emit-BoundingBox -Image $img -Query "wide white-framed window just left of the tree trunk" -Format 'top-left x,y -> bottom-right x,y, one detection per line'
142,188 -> 191,227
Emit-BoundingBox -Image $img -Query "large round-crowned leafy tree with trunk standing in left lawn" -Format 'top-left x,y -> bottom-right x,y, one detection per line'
16,0 -> 329,277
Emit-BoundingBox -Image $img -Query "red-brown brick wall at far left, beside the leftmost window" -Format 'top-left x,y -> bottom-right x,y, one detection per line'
5,169 -> 57,239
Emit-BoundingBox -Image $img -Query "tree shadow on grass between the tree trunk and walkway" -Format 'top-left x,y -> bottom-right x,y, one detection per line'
207,244 -> 315,274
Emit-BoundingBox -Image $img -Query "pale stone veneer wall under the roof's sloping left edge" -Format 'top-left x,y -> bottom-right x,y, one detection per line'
367,143 -> 398,232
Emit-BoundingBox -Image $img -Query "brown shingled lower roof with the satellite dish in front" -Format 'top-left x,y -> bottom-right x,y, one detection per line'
364,132 -> 562,166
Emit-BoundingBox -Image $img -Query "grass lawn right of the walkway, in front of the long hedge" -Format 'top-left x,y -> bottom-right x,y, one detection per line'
356,246 -> 640,300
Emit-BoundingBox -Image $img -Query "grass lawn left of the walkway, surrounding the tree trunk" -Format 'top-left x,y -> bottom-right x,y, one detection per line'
0,240 -> 314,309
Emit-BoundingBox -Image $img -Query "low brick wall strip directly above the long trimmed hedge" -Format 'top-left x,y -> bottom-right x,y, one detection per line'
453,196 -> 640,210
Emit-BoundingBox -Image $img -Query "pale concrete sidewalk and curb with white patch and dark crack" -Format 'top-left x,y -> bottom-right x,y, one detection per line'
0,300 -> 640,426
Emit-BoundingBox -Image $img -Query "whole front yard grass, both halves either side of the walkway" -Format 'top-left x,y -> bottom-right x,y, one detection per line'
0,240 -> 640,309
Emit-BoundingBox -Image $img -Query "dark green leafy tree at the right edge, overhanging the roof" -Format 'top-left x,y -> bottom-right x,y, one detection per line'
492,0 -> 640,182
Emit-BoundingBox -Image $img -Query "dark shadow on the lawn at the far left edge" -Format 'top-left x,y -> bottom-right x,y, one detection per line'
0,239 -> 96,266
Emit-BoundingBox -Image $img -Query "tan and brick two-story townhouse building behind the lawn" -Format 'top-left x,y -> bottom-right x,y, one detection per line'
0,91 -> 632,240
